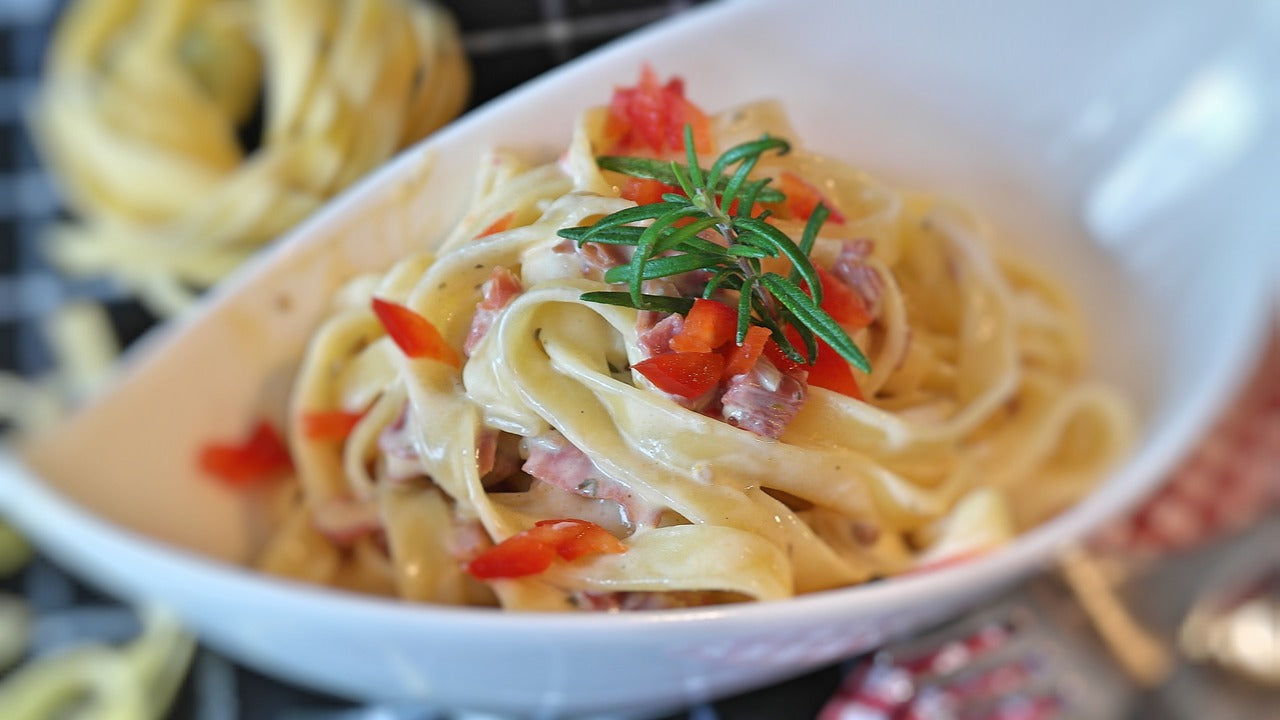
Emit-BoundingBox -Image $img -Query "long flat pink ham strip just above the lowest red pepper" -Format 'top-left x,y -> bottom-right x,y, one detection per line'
524,430 -> 662,527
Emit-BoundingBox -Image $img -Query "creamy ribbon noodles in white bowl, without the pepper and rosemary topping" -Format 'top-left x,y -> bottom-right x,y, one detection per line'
264,95 -> 1132,610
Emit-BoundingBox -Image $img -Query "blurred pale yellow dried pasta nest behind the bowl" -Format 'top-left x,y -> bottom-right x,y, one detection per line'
32,0 -> 471,315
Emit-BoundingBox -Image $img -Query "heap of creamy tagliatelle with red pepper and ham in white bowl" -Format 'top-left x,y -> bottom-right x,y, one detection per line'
247,70 -> 1130,610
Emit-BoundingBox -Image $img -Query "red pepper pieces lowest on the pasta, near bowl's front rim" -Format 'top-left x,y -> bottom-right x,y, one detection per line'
466,518 -> 627,580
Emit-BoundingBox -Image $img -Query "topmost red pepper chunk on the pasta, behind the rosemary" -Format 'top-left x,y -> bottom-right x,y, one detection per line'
604,65 -> 712,155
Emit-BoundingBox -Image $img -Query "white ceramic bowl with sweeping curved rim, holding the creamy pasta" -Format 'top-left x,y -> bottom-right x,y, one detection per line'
0,0 -> 1280,715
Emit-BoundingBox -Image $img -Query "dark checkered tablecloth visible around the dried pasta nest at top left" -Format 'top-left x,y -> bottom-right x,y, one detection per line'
0,0 -> 721,377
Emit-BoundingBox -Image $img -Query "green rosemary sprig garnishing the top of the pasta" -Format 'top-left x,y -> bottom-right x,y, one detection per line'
559,126 -> 870,373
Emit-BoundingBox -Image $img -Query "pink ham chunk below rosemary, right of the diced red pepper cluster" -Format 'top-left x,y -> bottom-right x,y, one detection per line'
721,357 -> 808,438
